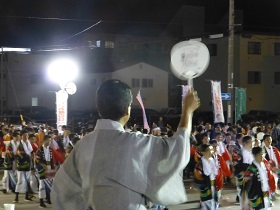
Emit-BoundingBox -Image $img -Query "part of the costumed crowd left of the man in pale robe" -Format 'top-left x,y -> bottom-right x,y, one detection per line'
0,122 -> 90,208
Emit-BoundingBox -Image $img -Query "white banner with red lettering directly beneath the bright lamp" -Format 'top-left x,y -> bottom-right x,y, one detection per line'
56,90 -> 68,131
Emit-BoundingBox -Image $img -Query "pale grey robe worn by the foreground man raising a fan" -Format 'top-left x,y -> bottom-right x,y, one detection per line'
51,119 -> 190,210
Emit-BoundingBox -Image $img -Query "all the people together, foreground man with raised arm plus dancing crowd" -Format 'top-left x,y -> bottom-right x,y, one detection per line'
0,80 -> 280,210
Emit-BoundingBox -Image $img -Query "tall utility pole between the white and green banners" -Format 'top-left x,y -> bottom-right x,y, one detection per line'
227,0 -> 235,123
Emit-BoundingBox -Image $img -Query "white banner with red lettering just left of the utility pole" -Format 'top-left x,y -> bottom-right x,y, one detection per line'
211,81 -> 225,123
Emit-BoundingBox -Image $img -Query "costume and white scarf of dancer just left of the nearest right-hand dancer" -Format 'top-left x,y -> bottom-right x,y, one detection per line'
232,147 -> 254,209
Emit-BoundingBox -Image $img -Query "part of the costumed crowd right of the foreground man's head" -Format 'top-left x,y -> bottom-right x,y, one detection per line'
131,118 -> 280,210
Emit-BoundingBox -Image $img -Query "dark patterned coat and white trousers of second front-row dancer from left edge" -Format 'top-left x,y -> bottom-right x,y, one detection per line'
15,140 -> 32,193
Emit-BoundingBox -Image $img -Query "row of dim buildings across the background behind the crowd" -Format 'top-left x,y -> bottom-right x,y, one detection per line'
2,6 -> 280,123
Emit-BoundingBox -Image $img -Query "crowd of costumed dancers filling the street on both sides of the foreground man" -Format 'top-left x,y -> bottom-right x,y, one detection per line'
0,117 -> 280,210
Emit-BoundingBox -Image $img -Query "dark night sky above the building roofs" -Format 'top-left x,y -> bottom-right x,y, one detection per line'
0,0 -> 280,47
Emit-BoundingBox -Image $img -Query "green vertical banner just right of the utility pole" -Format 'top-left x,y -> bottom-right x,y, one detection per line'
235,88 -> 247,122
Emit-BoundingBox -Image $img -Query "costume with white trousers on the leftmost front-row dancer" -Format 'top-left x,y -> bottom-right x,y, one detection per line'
2,140 -> 18,192
